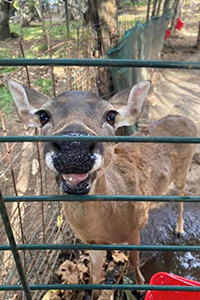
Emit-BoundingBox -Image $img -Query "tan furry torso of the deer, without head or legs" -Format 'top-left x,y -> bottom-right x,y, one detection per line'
64,116 -> 196,244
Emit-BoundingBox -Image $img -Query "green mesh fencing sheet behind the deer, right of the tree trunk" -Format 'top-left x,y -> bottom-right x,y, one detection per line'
107,15 -> 169,92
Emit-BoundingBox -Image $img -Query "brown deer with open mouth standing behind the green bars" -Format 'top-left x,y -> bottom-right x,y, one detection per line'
8,79 -> 197,299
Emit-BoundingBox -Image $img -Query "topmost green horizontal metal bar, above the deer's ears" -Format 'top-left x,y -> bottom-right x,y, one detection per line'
0,58 -> 200,69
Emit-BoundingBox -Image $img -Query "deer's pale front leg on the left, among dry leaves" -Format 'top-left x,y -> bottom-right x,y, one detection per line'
88,250 -> 106,300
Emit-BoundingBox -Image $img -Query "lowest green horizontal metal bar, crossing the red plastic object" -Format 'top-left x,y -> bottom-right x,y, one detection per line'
0,284 -> 200,292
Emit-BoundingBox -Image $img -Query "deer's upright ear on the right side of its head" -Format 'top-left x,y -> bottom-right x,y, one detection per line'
110,80 -> 151,129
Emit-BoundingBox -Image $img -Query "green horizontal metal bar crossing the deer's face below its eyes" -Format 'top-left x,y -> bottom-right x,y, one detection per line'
0,135 -> 200,144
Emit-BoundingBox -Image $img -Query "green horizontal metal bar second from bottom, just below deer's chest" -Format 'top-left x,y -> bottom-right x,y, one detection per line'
0,244 -> 200,252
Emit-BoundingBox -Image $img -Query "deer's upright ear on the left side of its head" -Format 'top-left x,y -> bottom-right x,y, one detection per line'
7,79 -> 49,127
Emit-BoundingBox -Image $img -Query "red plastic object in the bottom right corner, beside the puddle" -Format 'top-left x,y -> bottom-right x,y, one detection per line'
144,272 -> 200,300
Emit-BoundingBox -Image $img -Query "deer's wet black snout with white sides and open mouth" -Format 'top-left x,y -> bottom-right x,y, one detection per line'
45,132 -> 103,194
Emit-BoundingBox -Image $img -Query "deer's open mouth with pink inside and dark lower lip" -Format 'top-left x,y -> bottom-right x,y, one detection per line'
61,173 -> 90,195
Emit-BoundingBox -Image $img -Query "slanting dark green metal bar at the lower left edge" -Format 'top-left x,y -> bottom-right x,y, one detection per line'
0,191 -> 32,300
